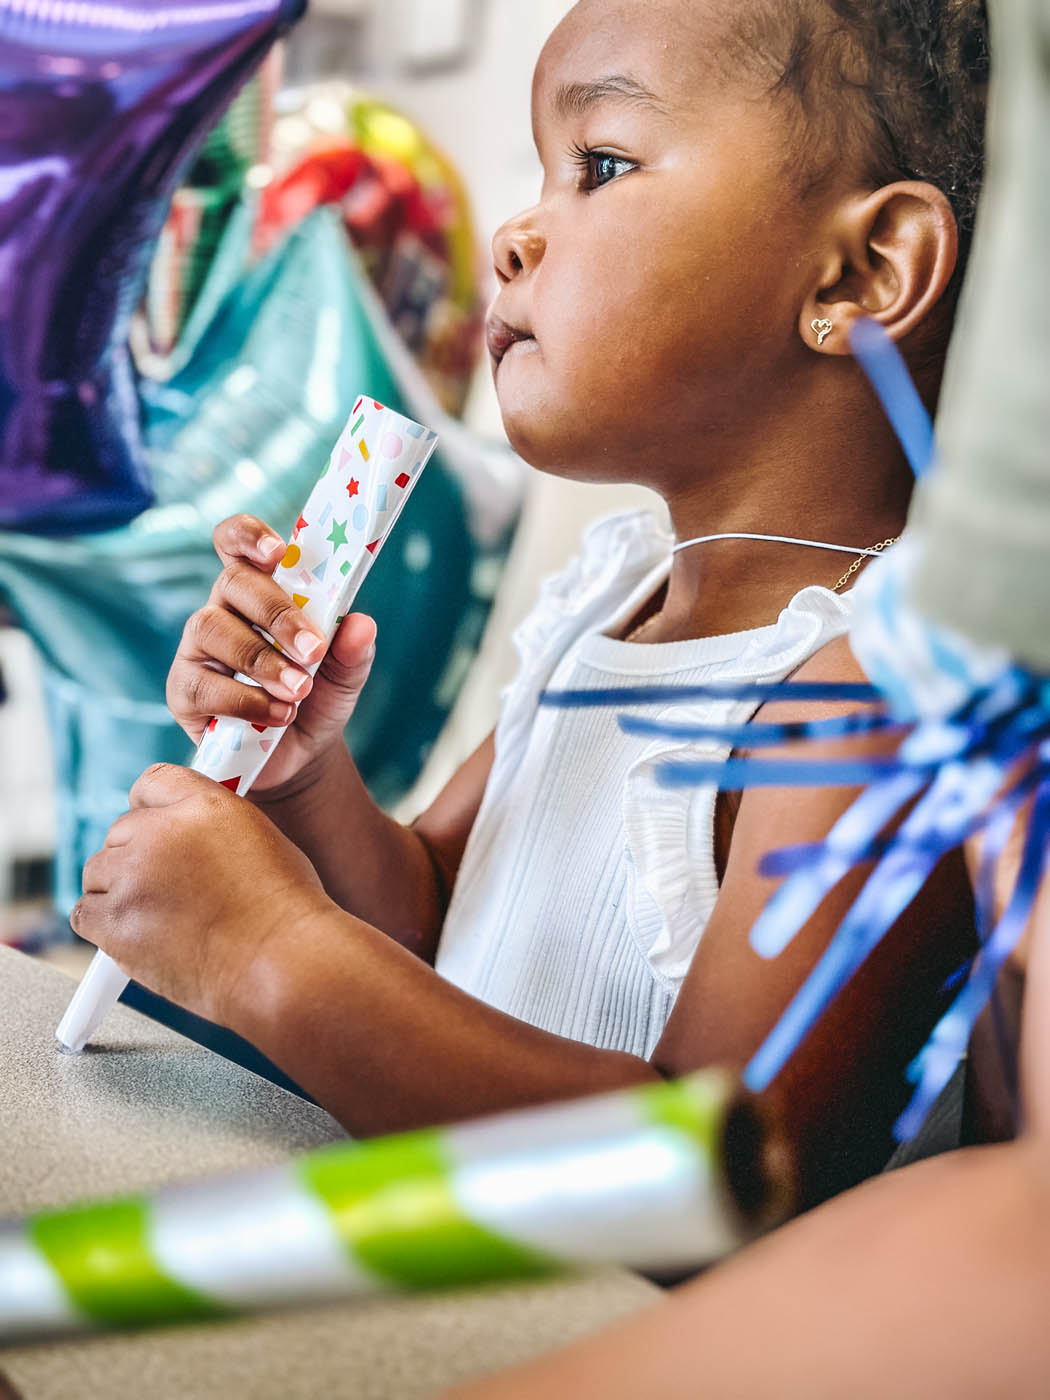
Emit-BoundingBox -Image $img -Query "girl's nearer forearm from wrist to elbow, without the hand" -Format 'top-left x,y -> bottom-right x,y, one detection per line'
236,910 -> 658,1135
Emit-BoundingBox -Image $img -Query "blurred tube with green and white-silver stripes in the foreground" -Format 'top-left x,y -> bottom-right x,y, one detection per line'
0,1072 -> 791,1343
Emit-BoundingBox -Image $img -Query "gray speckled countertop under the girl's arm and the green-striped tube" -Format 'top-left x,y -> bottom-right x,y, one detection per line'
0,948 -> 659,1400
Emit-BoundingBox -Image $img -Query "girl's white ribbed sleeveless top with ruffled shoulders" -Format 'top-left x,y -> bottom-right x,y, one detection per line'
437,512 -> 851,1058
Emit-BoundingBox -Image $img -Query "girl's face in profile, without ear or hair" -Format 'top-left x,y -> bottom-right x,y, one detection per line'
489,0 -> 834,489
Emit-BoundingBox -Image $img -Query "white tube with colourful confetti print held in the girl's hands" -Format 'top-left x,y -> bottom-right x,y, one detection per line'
56,398 -> 437,1053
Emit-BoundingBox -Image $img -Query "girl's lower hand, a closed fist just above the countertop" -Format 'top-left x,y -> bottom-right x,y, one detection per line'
70,763 -> 332,1025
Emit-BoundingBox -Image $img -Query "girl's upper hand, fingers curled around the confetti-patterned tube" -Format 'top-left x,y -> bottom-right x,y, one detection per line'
167,515 -> 375,791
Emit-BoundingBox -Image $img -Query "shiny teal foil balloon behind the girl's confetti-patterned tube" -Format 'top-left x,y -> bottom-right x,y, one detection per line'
0,209 -> 508,907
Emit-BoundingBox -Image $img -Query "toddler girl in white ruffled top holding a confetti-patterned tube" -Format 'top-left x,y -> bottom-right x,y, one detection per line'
73,0 -> 986,1200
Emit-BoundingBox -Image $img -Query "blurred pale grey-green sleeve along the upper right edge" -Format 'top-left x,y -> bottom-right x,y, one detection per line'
910,0 -> 1050,672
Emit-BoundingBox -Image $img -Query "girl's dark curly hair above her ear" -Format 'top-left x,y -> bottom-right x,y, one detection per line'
734,0 -> 988,273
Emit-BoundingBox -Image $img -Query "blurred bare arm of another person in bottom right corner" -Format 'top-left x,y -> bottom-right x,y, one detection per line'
449,881 -> 1050,1400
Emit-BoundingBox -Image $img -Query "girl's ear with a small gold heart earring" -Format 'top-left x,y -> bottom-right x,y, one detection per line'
799,181 -> 959,354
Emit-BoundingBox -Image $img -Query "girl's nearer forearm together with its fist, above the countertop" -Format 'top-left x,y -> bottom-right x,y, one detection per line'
70,764 -> 657,1134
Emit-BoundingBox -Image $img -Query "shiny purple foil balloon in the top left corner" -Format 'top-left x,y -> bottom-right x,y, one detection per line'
0,0 -> 304,533
